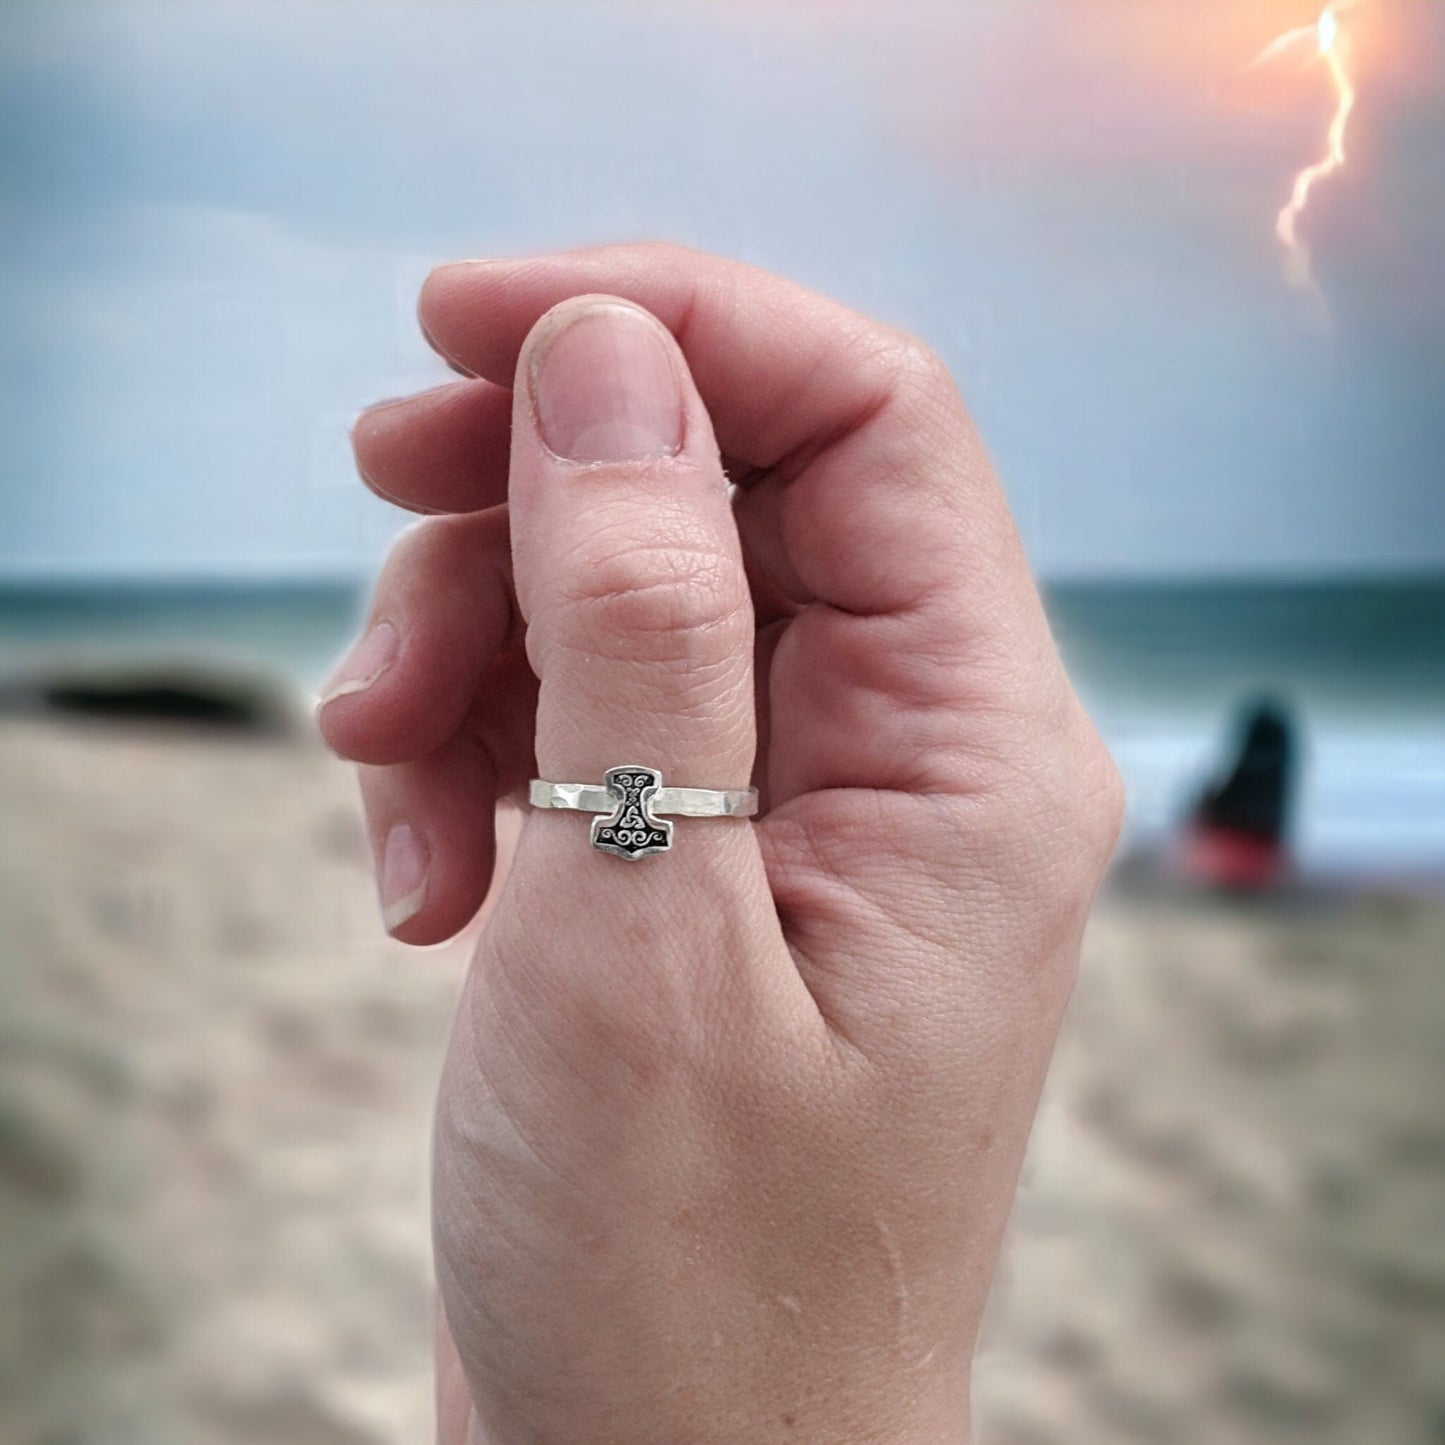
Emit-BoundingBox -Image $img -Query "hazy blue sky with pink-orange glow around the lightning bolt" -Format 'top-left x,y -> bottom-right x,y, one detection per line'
0,0 -> 1445,578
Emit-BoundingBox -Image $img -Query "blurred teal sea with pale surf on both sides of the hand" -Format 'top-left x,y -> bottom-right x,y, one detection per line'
0,575 -> 1445,879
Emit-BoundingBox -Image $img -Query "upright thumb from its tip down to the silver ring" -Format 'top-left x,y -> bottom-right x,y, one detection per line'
509,296 -> 756,864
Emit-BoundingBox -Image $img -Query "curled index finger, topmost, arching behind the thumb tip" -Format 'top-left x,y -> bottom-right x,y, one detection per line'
419,244 -> 1036,631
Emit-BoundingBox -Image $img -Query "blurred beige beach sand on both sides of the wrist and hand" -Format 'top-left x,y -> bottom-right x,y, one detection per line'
0,720 -> 1445,1445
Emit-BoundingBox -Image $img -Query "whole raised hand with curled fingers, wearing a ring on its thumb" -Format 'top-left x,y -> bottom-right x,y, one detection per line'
321,246 -> 1120,1445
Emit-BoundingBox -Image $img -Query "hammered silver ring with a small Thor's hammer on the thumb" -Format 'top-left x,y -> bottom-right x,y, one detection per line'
527,763 -> 757,860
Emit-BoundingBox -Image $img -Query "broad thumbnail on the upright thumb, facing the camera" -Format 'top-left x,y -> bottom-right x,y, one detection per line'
532,302 -> 682,461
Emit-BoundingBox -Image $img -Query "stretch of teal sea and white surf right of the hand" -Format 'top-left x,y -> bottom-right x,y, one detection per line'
1049,577 -> 1445,879
